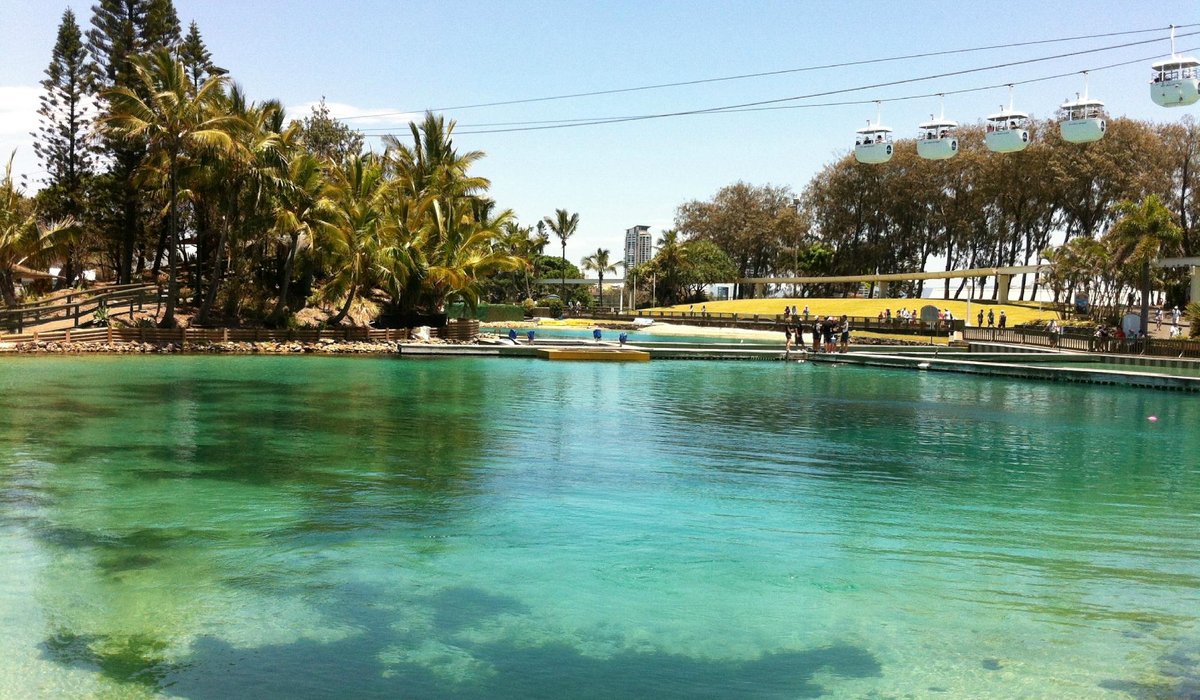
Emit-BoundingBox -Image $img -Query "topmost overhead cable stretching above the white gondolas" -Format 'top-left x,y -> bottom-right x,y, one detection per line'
341,23 -> 1200,121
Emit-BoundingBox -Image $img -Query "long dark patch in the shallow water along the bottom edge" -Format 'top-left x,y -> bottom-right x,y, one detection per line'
42,586 -> 882,700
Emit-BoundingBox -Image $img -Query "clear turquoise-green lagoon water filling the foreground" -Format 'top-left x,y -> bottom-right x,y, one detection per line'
0,357 -> 1200,698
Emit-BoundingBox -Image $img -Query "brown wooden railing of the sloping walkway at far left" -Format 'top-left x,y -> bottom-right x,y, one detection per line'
0,285 -> 161,334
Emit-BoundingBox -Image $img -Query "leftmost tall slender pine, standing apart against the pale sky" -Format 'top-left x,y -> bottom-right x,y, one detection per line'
32,10 -> 95,285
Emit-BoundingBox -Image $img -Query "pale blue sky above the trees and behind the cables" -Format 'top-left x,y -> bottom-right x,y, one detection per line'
0,0 -> 1200,262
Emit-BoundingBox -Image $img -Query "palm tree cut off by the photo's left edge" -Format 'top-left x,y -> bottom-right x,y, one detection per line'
0,154 -> 76,306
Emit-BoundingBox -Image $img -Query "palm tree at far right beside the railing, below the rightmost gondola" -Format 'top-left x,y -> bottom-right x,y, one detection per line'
1105,195 -> 1183,334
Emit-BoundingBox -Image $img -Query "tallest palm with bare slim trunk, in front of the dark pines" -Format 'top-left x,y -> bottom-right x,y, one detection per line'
102,49 -> 236,328
